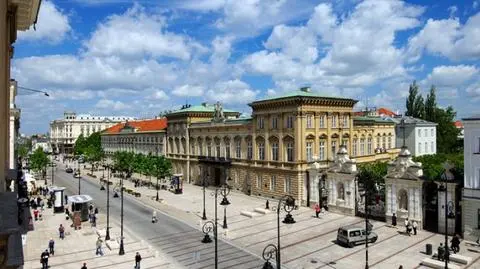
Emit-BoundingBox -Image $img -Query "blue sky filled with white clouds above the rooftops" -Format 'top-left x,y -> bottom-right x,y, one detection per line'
11,0 -> 480,134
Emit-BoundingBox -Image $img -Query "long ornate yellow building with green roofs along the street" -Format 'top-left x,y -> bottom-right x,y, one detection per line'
167,88 -> 398,203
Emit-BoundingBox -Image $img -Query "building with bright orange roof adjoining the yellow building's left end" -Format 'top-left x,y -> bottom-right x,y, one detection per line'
101,118 -> 167,156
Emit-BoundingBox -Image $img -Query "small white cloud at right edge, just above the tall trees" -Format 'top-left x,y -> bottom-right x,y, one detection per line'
423,65 -> 480,87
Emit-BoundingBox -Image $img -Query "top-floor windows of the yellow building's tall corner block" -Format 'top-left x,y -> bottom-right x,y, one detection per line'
257,114 -> 350,129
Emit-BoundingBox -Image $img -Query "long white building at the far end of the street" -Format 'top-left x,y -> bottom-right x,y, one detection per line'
50,111 -> 135,153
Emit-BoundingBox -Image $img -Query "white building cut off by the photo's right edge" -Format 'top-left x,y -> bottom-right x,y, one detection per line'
462,115 -> 480,241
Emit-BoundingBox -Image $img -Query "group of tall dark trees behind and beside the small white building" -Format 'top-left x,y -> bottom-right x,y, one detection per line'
405,81 -> 462,153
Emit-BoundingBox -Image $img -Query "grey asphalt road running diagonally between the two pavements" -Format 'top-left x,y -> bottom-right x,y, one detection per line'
49,165 -> 263,269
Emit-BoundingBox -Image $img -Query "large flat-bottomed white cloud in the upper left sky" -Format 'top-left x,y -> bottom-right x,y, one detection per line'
85,4 -> 203,60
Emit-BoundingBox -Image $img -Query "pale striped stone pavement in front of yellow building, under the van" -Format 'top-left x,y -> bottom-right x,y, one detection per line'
61,159 -> 480,269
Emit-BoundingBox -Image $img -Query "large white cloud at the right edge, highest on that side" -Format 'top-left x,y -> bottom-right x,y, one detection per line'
408,13 -> 480,61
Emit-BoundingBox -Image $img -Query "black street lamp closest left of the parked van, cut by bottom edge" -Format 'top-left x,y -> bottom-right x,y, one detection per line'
262,195 -> 295,269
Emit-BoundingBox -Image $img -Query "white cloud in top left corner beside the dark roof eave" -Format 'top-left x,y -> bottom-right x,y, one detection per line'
18,1 -> 72,44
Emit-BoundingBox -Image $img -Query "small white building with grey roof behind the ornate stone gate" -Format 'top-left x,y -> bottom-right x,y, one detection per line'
388,116 -> 437,156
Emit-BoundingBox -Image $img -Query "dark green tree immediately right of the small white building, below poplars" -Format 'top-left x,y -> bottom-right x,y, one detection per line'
435,106 -> 459,153
